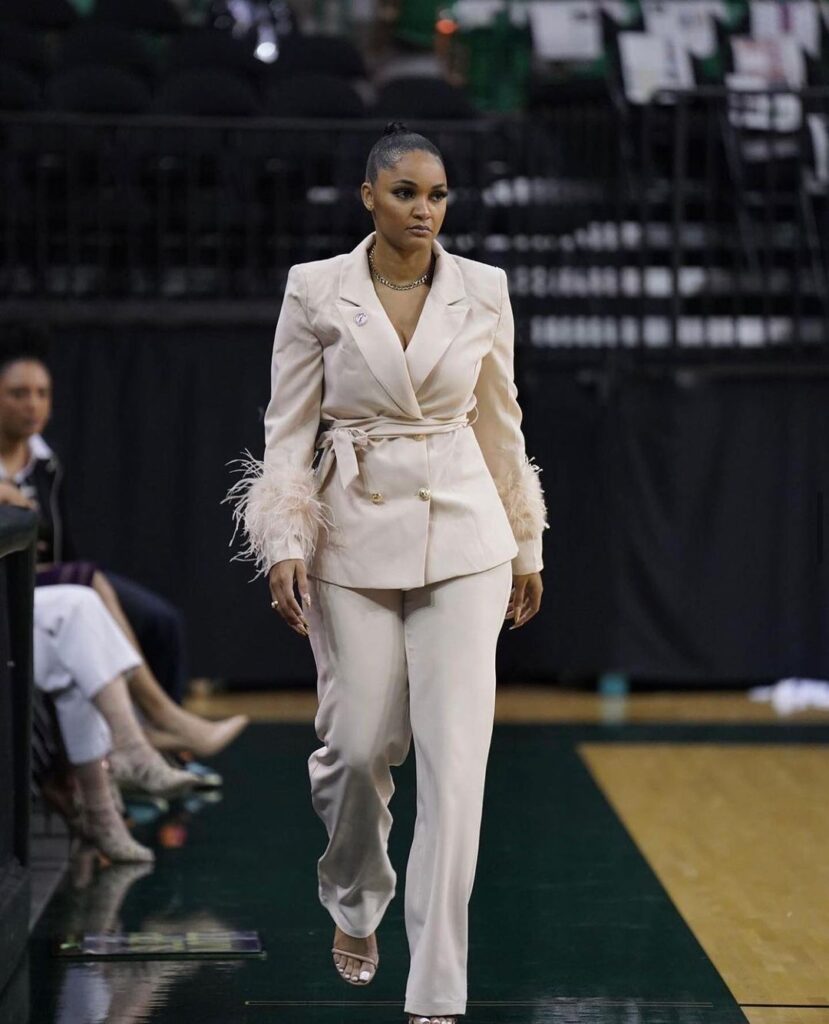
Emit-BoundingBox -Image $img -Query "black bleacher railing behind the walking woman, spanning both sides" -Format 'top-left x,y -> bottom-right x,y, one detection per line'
0,89 -> 829,359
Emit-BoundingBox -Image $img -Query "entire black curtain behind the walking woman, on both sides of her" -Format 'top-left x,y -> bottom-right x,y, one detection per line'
48,325 -> 829,683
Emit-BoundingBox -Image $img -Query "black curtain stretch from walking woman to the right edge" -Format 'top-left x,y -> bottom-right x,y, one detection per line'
524,369 -> 829,683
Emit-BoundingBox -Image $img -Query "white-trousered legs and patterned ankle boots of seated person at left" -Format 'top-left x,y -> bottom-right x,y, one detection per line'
34,584 -> 195,861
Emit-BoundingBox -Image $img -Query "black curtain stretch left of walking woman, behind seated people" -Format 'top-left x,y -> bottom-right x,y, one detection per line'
48,323 -> 313,680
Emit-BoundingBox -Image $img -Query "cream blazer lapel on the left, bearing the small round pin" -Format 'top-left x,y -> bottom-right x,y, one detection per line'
337,232 -> 423,420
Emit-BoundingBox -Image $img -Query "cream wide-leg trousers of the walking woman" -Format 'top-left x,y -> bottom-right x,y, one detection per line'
306,562 -> 512,1016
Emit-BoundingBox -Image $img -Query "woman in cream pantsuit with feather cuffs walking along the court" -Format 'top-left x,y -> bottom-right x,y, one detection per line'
230,123 -> 548,1021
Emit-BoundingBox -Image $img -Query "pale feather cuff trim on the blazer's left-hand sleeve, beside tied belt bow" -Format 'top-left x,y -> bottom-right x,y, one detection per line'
222,452 -> 334,579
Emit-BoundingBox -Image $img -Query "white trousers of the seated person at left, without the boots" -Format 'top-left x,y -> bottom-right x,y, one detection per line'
34,584 -> 141,765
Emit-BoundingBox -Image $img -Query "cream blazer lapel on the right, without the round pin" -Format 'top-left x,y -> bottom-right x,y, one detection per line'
397,241 -> 470,393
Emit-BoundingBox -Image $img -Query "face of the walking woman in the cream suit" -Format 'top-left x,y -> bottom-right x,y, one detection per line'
361,150 -> 447,253
